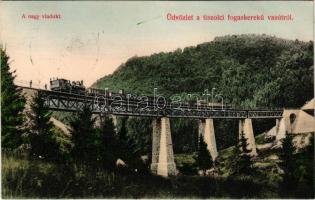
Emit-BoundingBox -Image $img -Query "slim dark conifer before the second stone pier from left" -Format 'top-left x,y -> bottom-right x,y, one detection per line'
195,135 -> 213,175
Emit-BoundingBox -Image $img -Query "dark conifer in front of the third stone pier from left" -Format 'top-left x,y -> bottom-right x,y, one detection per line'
232,132 -> 255,175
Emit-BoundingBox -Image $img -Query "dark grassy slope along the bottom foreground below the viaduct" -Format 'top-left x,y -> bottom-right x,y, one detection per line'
2,154 -> 267,198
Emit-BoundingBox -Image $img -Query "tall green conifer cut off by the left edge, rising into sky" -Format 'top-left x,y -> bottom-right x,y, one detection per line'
0,47 -> 25,148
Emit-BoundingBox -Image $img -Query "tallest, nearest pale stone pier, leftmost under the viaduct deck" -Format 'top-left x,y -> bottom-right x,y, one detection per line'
151,117 -> 177,177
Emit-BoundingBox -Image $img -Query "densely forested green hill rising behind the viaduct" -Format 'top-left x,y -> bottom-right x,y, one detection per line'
92,35 -> 314,107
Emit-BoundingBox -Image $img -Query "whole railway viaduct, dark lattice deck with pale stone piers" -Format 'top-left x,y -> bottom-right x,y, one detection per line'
22,87 -> 288,176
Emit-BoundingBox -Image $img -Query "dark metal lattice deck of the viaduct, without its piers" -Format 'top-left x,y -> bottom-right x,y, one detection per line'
22,87 -> 283,119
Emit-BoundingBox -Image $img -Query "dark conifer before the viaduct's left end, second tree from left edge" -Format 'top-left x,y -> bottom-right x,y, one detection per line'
27,92 -> 59,160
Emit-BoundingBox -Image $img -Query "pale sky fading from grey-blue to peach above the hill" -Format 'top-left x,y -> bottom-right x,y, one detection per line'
0,1 -> 313,87
